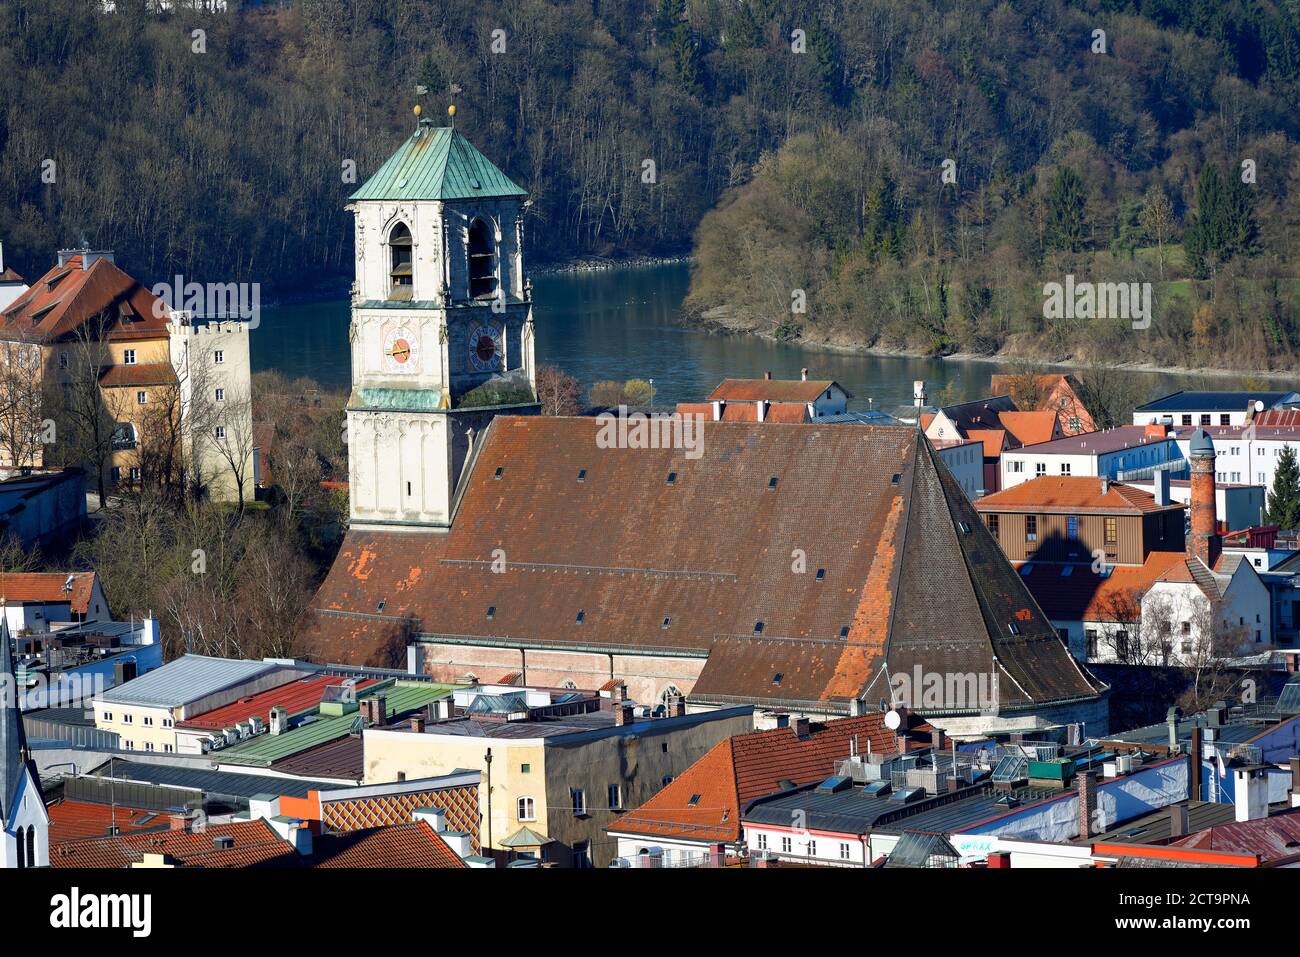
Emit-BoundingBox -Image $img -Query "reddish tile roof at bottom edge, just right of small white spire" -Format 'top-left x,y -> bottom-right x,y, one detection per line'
49,820 -> 299,869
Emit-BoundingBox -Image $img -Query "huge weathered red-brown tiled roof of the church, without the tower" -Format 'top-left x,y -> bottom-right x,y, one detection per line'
303,416 -> 1101,710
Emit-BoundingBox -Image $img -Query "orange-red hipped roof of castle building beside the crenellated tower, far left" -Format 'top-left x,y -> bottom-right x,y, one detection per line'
0,256 -> 168,342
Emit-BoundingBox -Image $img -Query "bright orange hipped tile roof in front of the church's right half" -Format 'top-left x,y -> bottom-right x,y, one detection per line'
607,713 -> 909,841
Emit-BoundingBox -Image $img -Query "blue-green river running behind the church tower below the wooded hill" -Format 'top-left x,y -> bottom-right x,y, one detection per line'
250,263 -> 1201,408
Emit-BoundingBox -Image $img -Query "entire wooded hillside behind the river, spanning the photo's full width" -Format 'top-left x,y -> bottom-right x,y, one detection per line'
0,0 -> 1300,368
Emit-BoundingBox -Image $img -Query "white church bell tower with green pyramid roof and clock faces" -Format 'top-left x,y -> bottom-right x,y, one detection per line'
346,107 -> 538,532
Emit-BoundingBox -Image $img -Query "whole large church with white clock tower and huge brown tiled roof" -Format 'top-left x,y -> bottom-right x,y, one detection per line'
303,111 -> 1109,736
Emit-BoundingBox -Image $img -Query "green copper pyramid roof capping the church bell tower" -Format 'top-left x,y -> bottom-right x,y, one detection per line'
352,120 -> 528,199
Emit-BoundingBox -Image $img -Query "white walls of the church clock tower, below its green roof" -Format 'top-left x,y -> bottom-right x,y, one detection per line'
347,185 -> 536,529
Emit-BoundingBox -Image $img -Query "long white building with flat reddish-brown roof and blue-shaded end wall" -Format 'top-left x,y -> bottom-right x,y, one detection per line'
1002,425 -> 1187,489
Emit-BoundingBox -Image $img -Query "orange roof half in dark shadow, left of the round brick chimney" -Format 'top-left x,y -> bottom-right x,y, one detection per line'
1017,551 -> 1192,622
